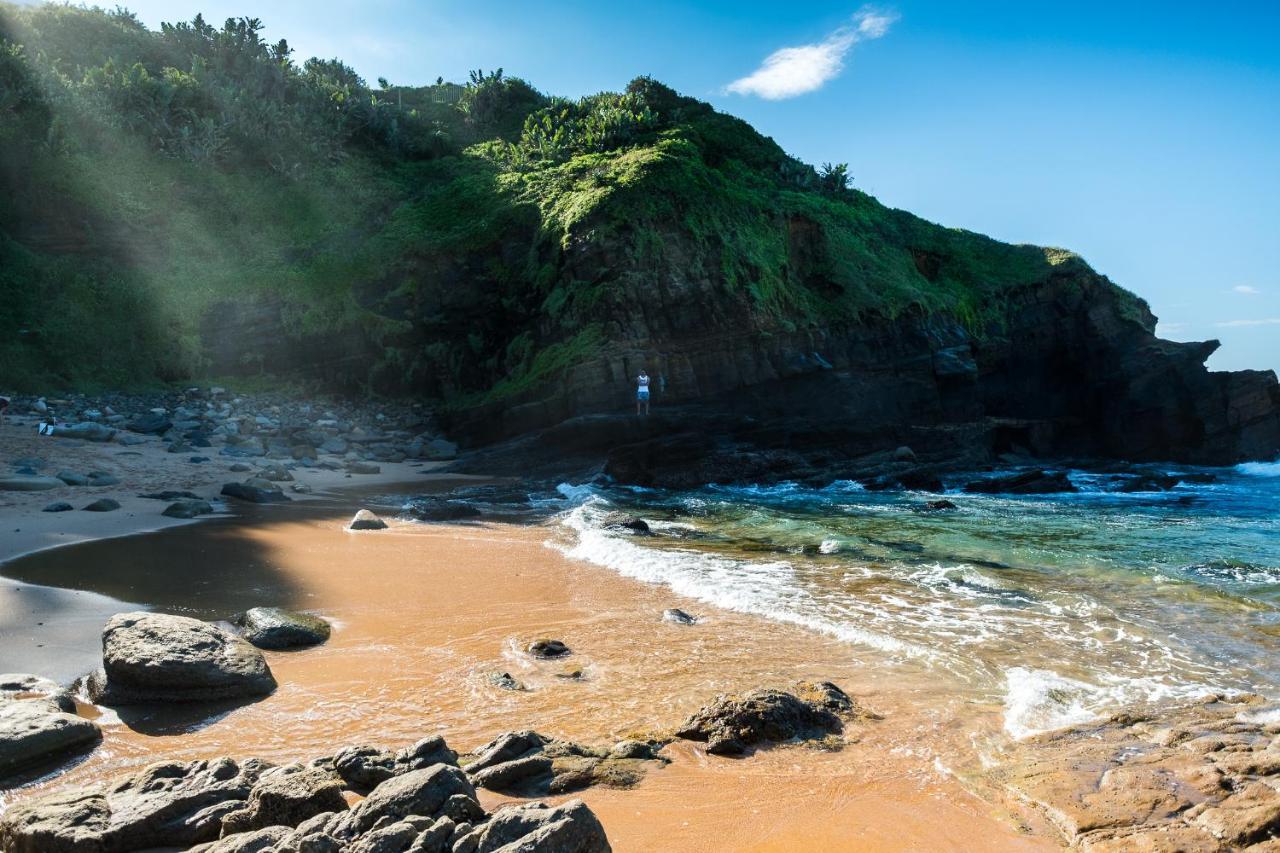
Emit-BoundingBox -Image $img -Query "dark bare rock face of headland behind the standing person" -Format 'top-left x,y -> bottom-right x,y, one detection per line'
435,222 -> 1280,485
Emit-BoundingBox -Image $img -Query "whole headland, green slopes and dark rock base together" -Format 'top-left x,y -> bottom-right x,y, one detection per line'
0,5 -> 1280,471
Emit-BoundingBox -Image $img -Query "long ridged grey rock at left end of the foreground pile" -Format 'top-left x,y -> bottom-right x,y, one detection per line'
0,758 -> 265,853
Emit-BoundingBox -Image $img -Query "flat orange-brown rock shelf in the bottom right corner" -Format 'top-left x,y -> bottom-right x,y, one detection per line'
997,695 -> 1280,853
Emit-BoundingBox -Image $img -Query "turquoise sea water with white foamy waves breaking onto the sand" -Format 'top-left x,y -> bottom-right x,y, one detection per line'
556,464 -> 1280,736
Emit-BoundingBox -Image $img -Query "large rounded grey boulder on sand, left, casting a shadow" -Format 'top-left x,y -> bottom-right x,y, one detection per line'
90,612 -> 275,706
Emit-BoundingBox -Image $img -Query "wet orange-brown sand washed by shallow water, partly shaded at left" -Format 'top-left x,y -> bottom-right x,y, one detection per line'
0,494 -> 1057,850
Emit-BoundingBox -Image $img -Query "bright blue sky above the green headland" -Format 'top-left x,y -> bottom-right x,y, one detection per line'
62,0 -> 1280,370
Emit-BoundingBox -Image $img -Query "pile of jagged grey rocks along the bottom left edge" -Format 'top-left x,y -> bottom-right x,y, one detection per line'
0,739 -> 611,853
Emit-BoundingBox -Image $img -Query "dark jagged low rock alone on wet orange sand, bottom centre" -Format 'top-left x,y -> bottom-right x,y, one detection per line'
676,685 -> 852,756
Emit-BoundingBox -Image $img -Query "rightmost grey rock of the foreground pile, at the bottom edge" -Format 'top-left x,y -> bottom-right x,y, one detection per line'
468,799 -> 613,853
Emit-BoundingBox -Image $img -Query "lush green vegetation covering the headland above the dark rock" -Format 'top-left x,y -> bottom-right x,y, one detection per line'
0,4 -> 1140,403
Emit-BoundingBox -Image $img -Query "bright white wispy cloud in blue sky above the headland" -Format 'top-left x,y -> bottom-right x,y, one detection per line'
726,6 -> 897,101
